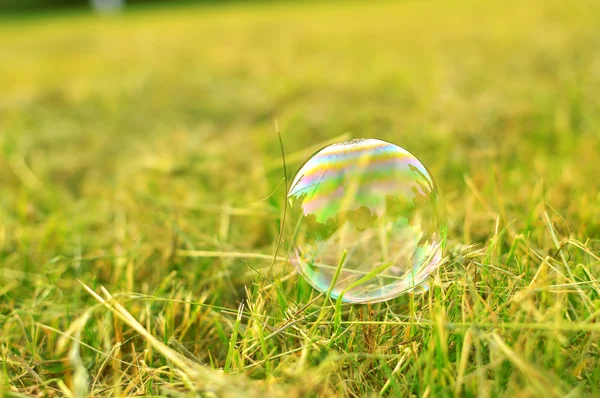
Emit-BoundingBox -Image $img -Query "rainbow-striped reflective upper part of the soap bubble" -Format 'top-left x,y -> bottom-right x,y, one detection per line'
288,139 -> 435,223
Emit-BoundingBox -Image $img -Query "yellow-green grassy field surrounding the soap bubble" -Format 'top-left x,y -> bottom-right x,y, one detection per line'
0,1 -> 600,398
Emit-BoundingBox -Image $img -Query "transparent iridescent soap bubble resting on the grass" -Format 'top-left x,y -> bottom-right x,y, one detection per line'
287,139 -> 446,303
